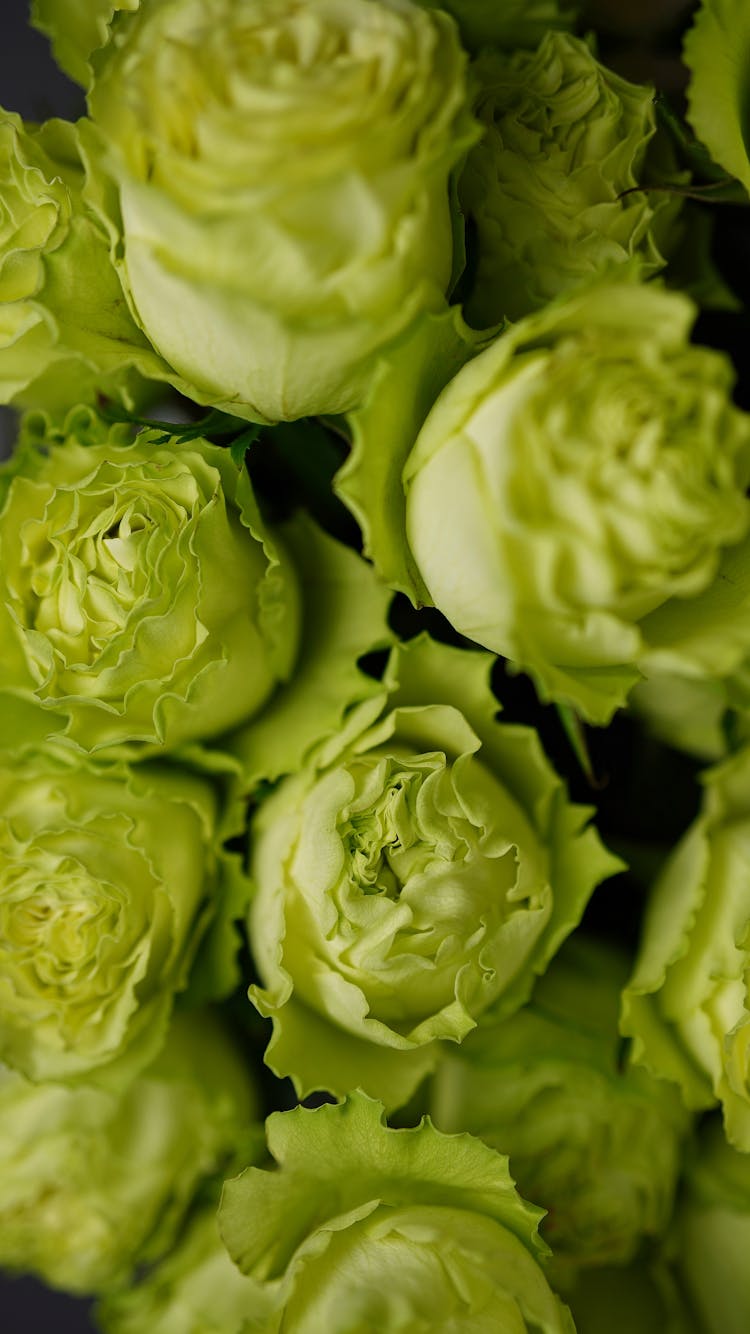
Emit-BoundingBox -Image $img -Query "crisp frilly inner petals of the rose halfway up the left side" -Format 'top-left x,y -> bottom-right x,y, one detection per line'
4,450 -> 198,700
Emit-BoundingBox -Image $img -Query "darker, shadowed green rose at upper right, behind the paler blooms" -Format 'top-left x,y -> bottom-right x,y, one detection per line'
459,32 -> 679,327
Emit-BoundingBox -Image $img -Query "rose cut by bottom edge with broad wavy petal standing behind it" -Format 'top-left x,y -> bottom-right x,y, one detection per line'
219,1094 -> 574,1334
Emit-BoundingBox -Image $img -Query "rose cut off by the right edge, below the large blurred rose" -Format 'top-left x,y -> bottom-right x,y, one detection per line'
622,747 -> 750,1153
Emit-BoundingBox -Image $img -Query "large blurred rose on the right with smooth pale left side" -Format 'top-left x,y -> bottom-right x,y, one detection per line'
397,283 -> 750,723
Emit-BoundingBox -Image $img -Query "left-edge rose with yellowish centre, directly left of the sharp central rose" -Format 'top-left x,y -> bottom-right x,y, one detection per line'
0,755 -> 236,1085
